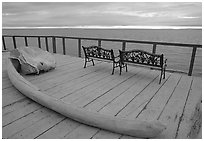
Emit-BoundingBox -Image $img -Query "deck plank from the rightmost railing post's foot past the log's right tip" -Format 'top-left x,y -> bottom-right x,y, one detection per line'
157,76 -> 192,139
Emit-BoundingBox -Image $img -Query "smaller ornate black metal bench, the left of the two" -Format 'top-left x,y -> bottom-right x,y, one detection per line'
82,46 -> 122,74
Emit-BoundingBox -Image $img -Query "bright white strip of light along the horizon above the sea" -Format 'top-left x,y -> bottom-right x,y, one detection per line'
2,26 -> 202,29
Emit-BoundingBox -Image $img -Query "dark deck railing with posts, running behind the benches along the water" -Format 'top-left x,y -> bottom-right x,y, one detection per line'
2,35 -> 202,76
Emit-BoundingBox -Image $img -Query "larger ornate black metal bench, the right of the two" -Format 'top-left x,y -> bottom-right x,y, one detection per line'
119,49 -> 167,84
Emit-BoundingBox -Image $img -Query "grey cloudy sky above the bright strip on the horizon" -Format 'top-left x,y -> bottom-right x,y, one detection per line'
2,2 -> 202,27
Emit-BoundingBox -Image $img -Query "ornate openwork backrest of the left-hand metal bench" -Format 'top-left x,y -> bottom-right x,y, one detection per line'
82,46 -> 114,60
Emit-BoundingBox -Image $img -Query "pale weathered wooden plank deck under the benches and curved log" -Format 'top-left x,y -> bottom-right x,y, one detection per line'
2,53 -> 202,139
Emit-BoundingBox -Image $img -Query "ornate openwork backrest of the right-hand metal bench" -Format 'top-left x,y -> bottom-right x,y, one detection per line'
119,50 -> 163,67
